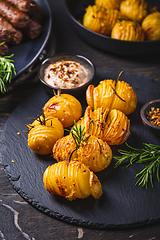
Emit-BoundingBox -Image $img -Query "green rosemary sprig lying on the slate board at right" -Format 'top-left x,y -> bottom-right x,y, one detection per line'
114,143 -> 160,189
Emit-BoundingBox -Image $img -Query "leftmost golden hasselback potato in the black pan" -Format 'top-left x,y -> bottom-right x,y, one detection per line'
83,5 -> 122,35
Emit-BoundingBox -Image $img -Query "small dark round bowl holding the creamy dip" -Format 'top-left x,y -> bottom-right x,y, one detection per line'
38,53 -> 95,96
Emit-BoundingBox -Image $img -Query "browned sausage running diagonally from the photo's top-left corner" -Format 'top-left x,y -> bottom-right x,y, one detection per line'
0,0 -> 29,29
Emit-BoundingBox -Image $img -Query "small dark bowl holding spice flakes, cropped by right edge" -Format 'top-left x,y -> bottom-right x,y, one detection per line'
140,99 -> 160,136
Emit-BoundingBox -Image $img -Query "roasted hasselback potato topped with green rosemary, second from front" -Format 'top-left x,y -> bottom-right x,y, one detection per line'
53,130 -> 112,172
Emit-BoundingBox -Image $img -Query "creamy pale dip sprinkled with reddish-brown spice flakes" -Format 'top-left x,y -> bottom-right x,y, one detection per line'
44,60 -> 89,89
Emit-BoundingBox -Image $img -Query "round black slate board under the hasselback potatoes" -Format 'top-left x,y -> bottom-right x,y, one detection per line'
0,70 -> 160,229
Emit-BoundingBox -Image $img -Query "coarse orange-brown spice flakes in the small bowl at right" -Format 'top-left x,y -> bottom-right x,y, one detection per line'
146,107 -> 160,127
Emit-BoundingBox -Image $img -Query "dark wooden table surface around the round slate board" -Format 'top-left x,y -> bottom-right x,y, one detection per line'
0,0 -> 160,240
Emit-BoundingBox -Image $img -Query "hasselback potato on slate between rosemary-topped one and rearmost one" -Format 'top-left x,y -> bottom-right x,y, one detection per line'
77,106 -> 130,145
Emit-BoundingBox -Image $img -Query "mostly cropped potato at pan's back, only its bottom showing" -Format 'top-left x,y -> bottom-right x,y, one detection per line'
95,0 -> 122,9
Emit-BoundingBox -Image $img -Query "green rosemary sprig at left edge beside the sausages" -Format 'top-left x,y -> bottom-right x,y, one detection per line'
0,42 -> 16,93
